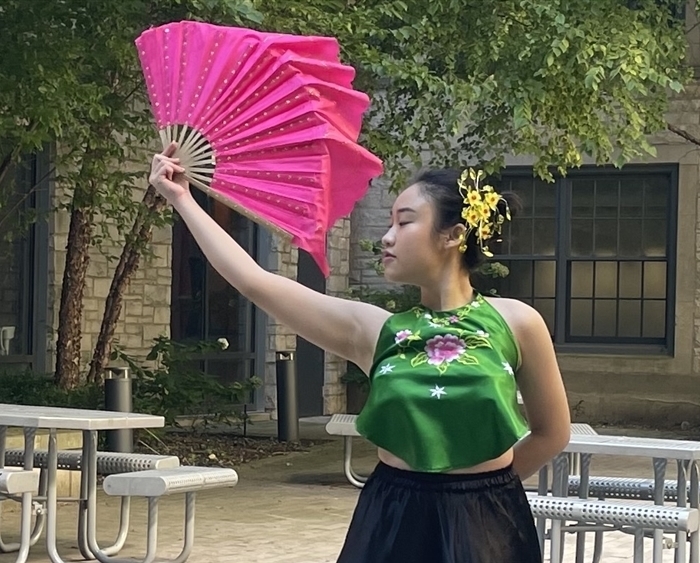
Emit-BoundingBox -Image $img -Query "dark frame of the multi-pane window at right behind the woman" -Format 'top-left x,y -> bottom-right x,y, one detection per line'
494,163 -> 679,355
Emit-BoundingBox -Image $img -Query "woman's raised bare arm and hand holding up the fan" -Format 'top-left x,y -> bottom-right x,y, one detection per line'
150,144 -> 389,373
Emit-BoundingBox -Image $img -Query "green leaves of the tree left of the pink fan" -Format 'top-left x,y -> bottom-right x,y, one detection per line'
0,0 -> 260,254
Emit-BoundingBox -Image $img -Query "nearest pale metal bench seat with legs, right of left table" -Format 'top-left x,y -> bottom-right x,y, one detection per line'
93,466 -> 238,563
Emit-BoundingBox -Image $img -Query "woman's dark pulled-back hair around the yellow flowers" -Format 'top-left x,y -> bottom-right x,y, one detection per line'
411,168 -> 522,271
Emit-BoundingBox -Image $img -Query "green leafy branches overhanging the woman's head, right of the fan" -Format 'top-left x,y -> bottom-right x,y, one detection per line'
255,0 -> 690,185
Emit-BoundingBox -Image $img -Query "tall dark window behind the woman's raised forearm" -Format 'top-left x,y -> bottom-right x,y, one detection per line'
171,190 -> 257,392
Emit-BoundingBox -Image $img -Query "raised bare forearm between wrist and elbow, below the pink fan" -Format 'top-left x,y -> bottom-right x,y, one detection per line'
173,193 -> 264,297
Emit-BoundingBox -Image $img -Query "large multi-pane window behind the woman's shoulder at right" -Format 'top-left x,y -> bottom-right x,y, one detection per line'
486,166 -> 677,351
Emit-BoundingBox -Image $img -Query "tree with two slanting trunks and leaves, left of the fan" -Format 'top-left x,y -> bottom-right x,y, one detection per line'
0,0 -> 256,388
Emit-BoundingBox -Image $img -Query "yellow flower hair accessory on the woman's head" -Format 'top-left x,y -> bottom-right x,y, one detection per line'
459,168 -> 510,257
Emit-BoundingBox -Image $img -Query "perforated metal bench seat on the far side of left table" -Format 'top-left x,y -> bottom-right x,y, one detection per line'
5,449 -> 180,475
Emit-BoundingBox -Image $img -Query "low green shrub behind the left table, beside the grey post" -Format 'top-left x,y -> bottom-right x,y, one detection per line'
112,337 -> 262,428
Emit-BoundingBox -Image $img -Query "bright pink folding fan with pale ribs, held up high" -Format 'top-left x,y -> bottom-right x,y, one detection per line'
136,21 -> 382,276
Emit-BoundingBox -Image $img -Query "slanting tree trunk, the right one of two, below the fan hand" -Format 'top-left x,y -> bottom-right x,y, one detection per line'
87,186 -> 165,382
